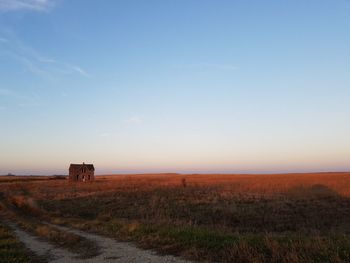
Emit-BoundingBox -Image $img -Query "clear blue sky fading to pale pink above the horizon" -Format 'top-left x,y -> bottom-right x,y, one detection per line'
0,0 -> 350,174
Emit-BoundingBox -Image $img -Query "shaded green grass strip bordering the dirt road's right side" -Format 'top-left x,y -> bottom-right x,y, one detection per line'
63,219 -> 350,262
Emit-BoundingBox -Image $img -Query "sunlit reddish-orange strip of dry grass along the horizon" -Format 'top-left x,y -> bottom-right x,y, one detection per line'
4,173 -> 350,199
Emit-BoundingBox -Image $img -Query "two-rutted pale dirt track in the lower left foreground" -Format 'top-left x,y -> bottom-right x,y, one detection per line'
10,224 -> 188,263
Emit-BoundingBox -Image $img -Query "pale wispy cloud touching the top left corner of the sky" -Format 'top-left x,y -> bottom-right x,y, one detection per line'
0,0 -> 54,11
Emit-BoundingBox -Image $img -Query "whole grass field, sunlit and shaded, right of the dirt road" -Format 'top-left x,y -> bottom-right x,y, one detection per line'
0,173 -> 350,262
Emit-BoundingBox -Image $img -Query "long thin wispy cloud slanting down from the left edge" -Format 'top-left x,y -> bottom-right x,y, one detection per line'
0,33 -> 91,78
